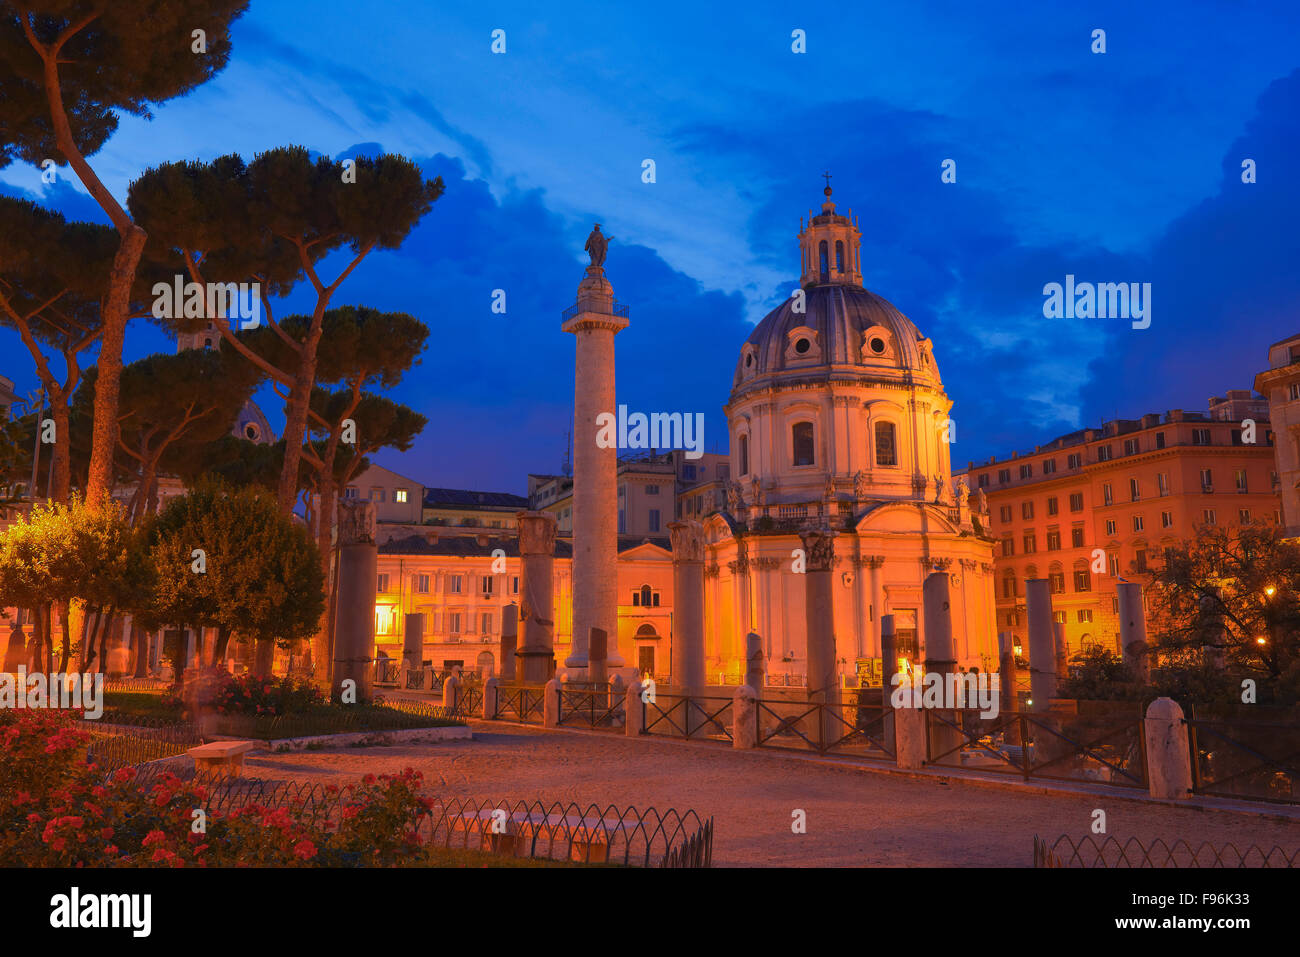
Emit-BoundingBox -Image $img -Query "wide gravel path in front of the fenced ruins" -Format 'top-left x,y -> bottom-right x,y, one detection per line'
236,722 -> 1300,867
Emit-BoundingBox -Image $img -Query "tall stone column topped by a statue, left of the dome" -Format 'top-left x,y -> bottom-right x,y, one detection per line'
562,222 -> 628,668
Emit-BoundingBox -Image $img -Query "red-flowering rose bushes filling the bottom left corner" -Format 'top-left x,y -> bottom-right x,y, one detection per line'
0,709 -> 430,867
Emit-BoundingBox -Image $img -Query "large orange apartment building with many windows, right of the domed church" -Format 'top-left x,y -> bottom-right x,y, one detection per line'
966,390 -> 1282,654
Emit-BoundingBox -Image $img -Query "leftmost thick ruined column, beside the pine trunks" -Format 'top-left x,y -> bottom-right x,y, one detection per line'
330,498 -> 380,703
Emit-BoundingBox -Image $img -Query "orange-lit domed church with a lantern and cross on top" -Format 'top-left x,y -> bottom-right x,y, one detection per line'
705,185 -> 997,681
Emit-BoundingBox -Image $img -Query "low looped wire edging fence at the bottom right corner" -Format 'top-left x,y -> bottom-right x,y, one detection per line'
1034,835 -> 1300,867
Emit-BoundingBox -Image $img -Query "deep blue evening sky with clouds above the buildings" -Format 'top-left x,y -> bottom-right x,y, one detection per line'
0,0 -> 1300,492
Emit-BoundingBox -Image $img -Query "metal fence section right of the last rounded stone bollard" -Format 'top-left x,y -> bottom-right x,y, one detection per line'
1187,718 -> 1300,804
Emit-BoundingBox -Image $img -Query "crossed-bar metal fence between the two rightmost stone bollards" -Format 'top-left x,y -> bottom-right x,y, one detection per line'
924,709 -> 1147,788
